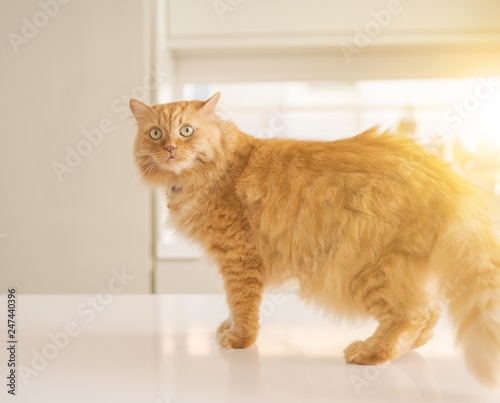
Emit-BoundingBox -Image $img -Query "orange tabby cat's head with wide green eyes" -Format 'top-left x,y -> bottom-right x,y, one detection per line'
130,93 -> 222,185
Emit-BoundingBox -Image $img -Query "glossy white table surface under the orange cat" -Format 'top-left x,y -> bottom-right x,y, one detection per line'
0,294 -> 500,403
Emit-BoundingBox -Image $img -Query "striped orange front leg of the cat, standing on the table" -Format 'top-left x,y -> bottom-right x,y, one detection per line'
217,259 -> 263,349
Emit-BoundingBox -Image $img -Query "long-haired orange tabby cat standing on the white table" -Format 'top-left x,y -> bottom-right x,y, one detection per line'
130,93 -> 500,385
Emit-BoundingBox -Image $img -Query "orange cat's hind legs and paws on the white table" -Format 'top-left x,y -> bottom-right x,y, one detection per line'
344,254 -> 432,365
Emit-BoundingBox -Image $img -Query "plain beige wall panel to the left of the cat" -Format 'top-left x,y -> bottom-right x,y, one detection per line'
0,0 -> 152,293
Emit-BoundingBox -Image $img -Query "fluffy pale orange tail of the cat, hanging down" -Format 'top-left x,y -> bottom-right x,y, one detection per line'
437,217 -> 500,388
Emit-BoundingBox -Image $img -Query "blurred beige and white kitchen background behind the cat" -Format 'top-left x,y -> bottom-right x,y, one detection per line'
0,0 -> 500,294
